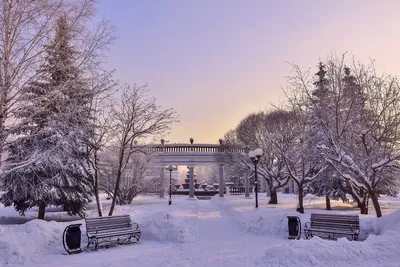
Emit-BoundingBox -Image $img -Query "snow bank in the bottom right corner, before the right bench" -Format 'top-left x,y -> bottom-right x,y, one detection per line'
259,231 -> 400,267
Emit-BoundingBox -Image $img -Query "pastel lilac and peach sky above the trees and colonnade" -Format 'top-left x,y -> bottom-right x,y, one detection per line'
100,0 -> 400,143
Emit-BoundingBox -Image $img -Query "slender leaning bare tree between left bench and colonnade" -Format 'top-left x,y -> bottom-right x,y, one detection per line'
109,85 -> 177,216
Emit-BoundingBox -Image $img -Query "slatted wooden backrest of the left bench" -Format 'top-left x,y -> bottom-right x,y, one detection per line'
85,215 -> 132,233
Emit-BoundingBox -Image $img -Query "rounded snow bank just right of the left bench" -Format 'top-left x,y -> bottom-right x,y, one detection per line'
139,211 -> 195,243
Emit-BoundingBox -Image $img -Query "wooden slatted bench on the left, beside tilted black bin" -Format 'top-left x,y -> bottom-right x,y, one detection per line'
85,215 -> 141,250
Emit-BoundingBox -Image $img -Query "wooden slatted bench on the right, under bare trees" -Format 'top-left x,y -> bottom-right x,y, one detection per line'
304,213 -> 360,241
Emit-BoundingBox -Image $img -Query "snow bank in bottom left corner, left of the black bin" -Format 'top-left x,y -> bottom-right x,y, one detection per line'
0,220 -> 64,266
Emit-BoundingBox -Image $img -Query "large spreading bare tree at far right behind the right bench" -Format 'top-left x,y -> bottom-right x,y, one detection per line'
289,56 -> 400,217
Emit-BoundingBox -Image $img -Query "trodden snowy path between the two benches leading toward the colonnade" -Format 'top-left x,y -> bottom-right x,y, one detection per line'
19,201 -> 287,267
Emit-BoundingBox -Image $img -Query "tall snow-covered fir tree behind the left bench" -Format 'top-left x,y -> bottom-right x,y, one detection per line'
0,16 -> 93,219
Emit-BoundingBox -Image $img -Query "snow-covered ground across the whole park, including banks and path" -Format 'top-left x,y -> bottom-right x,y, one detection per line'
0,194 -> 400,267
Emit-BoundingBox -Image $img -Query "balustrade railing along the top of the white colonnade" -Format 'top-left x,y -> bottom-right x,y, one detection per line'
147,144 -> 248,153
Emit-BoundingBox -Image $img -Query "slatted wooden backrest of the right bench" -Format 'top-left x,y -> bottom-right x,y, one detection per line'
310,213 -> 360,230
